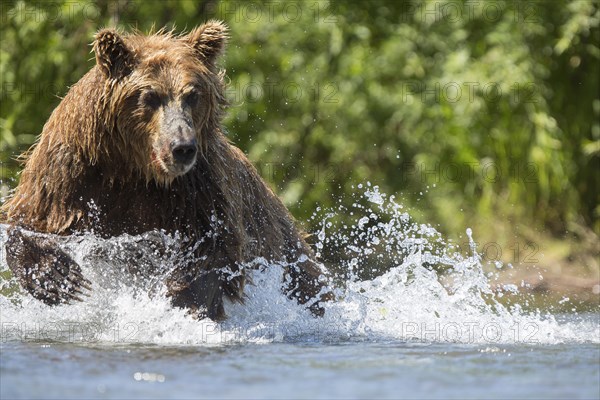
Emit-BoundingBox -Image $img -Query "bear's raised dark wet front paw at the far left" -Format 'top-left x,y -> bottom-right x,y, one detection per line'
6,227 -> 91,305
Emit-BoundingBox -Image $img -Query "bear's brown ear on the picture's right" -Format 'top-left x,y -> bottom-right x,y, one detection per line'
183,20 -> 229,65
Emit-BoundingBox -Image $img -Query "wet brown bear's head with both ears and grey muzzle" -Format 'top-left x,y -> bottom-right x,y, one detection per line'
93,21 -> 227,185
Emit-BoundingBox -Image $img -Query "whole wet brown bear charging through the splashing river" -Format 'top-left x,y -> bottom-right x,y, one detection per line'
1,21 -> 331,320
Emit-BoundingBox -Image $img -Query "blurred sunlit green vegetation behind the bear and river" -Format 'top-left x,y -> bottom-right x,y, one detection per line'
0,0 -> 600,304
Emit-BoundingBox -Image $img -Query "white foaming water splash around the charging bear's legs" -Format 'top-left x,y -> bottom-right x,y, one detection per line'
0,184 -> 600,345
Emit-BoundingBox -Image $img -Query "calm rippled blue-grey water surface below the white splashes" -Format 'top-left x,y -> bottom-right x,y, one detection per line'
0,340 -> 600,399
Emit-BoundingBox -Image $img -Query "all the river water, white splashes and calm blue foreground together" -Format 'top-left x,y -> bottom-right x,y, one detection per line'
0,187 -> 600,399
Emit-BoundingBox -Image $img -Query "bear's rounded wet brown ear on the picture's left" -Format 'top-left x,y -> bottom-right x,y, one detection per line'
94,29 -> 133,79
